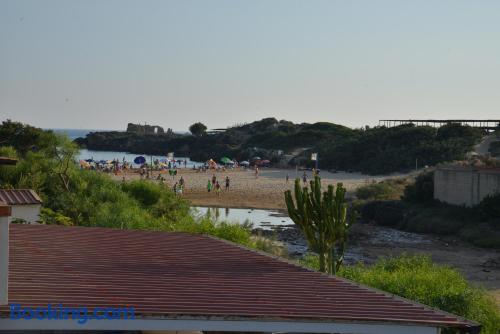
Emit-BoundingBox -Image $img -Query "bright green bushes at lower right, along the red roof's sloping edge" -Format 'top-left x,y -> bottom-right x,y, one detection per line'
299,254 -> 500,334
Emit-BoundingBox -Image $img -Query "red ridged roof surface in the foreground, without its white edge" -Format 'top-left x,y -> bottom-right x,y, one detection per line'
0,224 -> 475,327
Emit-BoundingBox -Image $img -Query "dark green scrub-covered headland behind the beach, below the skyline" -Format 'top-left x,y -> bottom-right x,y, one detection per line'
77,118 -> 483,174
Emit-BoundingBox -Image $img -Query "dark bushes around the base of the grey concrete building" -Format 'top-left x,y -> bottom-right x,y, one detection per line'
355,172 -> 500,249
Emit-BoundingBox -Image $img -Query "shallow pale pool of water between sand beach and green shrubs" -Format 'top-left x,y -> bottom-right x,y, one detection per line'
193,206 -> 293,229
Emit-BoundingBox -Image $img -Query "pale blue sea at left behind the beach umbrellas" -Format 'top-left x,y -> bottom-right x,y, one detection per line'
50,129 -> 202,168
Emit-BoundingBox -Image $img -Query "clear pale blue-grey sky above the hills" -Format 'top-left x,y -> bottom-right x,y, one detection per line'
0,0 -> 500,131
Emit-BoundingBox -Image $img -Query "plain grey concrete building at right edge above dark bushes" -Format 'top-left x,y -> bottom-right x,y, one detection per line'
434,166 -> 500,207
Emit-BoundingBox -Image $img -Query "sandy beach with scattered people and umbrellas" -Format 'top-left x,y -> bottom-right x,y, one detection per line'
115,168 -> 401,209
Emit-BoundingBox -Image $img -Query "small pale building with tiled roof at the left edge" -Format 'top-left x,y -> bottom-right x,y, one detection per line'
0,189 -> 42,223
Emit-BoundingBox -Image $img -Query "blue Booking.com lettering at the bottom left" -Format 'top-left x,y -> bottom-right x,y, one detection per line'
9,304 -> 135,325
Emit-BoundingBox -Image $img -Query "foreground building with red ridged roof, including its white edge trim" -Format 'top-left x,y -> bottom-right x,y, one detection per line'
0,219 -> 480,334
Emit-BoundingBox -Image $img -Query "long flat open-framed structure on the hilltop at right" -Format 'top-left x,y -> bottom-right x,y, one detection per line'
378,119 -> 500,131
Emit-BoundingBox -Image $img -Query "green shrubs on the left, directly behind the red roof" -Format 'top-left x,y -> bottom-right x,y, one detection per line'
0,121 -> 259,247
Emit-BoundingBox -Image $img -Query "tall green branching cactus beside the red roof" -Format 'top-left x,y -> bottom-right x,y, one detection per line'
285,176 -> 354,274
